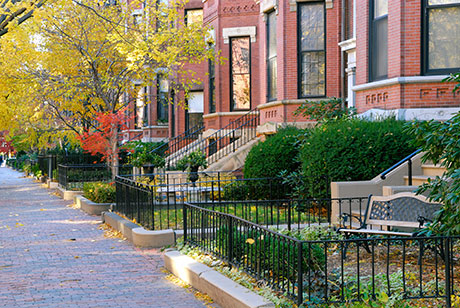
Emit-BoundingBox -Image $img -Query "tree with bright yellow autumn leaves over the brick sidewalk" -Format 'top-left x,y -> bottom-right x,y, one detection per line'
0,0 -> 217,174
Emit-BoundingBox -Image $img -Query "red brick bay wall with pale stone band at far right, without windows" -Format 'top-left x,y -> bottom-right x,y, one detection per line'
354,0 -> 460,113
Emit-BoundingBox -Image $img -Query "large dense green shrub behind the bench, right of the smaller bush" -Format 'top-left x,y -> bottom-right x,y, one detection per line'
299,119 -> 415,185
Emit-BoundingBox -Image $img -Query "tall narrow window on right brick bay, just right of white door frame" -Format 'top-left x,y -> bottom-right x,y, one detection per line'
369,0 -> 388,81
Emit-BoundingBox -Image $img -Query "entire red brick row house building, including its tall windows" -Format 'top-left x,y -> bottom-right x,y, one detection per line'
121,0 -> 460,167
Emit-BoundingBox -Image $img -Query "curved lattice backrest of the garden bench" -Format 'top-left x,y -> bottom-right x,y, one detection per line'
365,193 -> 441,228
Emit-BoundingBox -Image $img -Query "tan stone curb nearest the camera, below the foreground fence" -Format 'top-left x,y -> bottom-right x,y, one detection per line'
164,250 -> 275,308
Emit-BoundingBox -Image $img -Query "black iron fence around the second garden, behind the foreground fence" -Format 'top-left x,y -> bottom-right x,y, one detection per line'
114,173 -> 342,230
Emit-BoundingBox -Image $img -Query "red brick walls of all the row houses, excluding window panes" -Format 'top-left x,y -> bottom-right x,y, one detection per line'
122,0 -> 460,143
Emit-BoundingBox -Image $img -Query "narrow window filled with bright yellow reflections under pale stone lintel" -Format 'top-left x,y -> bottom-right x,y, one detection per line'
230,37 -> 251,110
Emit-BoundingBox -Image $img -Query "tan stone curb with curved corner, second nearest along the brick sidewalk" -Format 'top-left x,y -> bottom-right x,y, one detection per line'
101,212 -> 176,248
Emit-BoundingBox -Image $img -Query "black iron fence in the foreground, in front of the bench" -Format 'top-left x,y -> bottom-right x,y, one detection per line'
183,203 -> 460,307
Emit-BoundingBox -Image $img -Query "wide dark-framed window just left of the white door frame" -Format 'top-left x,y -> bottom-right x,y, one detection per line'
297,2 -> 326,97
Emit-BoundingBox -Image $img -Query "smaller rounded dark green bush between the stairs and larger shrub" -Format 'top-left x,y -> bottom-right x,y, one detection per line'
243,126 -> 303,178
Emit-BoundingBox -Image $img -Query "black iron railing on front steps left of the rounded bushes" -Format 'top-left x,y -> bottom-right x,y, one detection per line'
166,109 -> 260,167
